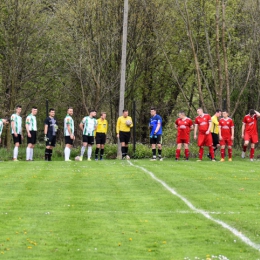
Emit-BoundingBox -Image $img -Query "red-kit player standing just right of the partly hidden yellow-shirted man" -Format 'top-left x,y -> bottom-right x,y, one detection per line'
219,110 -> 234,162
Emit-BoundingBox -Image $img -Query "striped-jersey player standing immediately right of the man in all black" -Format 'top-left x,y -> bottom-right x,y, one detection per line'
64,107 -> 75,161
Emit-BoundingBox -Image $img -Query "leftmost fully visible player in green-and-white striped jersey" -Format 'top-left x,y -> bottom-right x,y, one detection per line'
11,105 -> 23,161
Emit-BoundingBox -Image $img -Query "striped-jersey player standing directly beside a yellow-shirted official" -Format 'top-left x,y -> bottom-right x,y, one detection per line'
79,110 -> 97,161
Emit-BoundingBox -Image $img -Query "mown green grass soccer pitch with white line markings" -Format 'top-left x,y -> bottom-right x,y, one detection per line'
0,160 -> 260,260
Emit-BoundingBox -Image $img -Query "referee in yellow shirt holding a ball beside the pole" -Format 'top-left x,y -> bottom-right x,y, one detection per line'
116,109 -> 133,160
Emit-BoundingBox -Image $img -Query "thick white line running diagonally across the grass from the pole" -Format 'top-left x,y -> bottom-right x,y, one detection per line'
127,161 -> 260,250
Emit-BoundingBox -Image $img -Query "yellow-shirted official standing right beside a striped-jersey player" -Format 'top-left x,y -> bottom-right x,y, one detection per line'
95,112 -> 108,161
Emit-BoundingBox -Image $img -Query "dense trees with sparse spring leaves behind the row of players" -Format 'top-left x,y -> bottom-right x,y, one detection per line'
0,0 -> 260,148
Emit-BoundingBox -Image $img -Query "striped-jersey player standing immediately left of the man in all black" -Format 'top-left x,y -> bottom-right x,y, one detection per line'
25,107 -> 38,161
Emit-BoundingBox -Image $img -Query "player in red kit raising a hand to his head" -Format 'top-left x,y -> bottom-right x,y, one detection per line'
241,109 -> 260,161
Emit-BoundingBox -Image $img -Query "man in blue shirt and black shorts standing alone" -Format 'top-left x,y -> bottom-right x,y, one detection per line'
149,107 -> 163,161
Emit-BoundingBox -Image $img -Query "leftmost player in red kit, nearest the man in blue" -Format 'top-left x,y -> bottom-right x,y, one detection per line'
175,111 -> 193,161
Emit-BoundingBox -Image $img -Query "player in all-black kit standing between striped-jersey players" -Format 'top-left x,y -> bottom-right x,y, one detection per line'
44,108 -> 58,161
